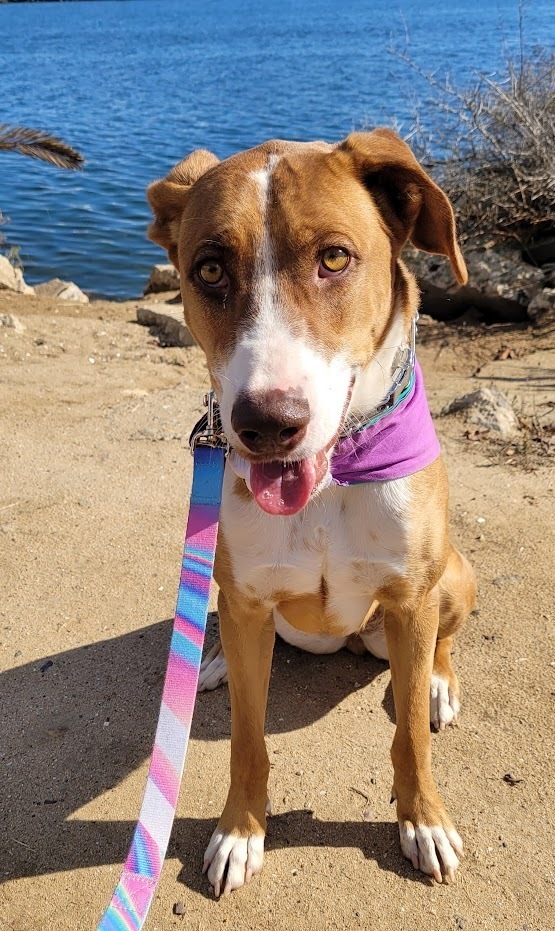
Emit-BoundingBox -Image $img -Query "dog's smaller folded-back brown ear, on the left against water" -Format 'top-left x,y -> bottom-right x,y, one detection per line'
146,149 -> 219,271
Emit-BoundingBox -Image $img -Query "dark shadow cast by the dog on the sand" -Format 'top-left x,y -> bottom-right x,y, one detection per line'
0,616 -> 406,893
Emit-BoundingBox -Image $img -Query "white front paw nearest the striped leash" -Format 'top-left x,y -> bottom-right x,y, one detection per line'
202,828 -> 264,898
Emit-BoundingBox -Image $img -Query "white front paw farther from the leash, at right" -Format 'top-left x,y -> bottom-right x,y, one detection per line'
399,821 -> 463,883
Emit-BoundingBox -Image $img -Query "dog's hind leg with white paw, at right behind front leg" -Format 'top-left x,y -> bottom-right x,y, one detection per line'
430,546 -> 476,730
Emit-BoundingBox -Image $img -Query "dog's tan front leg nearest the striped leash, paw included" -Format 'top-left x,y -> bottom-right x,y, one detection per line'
204,592 -> 275,896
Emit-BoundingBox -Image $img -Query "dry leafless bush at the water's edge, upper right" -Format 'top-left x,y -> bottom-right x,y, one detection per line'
390,26 -> 555,245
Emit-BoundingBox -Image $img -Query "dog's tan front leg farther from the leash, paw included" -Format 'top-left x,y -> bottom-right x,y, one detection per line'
385,588 -> 462,882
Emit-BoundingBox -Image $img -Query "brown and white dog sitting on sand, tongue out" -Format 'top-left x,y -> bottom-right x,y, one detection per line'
148,129 -> 475,895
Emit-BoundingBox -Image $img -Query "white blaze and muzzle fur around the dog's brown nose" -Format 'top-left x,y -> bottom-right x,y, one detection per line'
215,155 -> 351,459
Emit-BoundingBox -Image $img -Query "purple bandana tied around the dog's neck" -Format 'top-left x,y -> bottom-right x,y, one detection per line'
331,362 -> 440,485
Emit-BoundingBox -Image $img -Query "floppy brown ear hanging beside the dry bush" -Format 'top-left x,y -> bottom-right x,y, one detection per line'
338,129 -> 468,284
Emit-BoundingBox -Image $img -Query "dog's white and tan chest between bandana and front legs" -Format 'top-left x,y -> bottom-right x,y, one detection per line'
221,470 -> 410,634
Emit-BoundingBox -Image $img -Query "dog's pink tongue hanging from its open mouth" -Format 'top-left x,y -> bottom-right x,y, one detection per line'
250,456 -> 317,515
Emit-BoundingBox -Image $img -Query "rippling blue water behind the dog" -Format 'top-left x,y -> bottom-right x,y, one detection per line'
0,0 -> 555,297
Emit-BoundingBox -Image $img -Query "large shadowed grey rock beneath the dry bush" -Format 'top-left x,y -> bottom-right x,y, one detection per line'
406,244 -> 547,323
